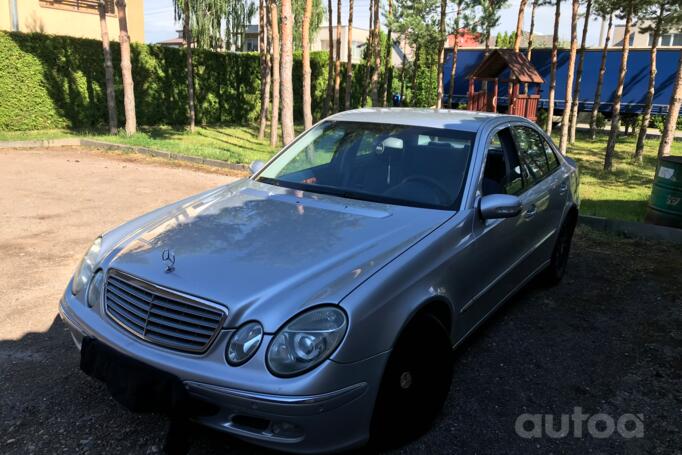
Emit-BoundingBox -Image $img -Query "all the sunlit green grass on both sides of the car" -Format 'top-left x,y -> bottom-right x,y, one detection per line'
0,125 -> 682,221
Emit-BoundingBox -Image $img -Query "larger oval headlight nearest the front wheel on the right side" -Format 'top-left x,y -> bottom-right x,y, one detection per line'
267,306 -> 347,376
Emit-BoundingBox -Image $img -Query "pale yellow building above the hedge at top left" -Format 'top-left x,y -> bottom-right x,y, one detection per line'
0,0 -> 144,42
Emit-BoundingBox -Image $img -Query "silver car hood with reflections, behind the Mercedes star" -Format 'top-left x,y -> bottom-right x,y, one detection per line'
108,180 -> 453,332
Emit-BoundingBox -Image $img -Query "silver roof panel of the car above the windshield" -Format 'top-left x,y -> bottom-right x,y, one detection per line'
327,107 -> 520,133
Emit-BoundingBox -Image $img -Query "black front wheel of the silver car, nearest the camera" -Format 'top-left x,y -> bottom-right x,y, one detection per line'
370,315 -> 454,449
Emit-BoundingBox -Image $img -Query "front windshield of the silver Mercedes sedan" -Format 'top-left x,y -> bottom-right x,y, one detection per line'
257,121 -> 475,210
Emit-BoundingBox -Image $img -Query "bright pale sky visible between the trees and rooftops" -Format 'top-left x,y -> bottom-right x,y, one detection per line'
144,0 -> 601,46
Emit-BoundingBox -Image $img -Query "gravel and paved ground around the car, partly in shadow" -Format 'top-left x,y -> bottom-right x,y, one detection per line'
0,149 -> 682,454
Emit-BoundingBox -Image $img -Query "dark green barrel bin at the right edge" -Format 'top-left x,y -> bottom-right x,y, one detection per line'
646,156 -> 682,228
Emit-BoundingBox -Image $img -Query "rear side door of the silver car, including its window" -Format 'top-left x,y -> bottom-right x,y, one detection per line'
512,124 -> 568,273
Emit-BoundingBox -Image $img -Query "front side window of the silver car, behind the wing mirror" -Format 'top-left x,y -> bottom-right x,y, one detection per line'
482,128 -> 527,195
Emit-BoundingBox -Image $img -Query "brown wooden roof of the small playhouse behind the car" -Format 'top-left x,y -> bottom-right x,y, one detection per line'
468,49 -> 544,84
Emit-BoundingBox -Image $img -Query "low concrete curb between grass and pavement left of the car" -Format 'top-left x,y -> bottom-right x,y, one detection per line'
0,138 -> 250,172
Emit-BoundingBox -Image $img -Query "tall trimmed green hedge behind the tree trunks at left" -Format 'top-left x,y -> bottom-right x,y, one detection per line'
0,32 -> 332,131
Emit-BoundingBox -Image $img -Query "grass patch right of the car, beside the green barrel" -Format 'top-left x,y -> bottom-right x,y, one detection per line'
554,133 -> 682,221
